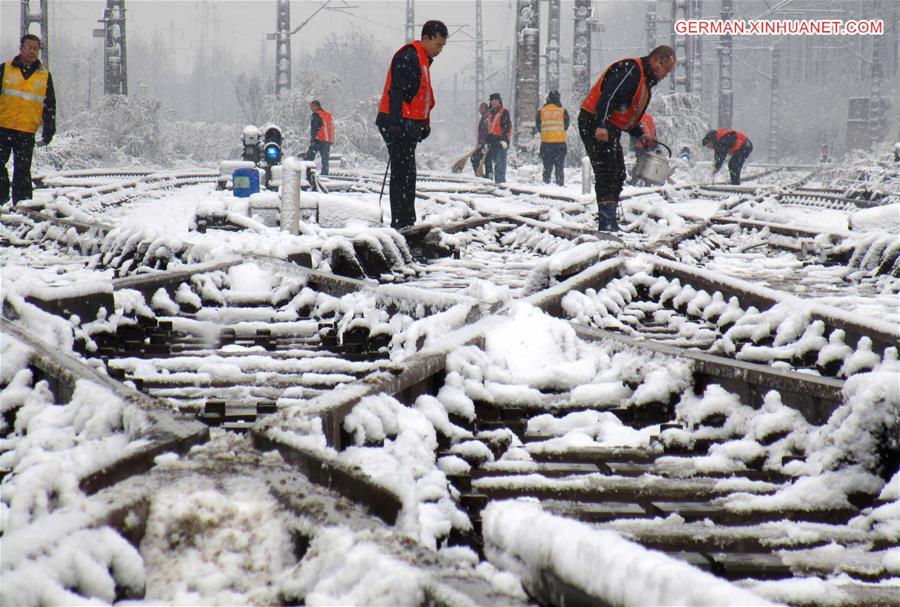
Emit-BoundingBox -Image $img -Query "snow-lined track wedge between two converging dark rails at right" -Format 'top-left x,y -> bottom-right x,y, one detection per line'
559,257 -> 900,377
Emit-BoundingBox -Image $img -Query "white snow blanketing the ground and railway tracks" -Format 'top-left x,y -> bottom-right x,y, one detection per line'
0,153 -> 900,605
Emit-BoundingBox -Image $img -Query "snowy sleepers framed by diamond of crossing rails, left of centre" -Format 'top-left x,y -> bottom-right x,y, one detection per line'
40,258 -> 472,429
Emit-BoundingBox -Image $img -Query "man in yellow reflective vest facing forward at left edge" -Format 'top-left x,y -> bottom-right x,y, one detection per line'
0,34 -> 56,205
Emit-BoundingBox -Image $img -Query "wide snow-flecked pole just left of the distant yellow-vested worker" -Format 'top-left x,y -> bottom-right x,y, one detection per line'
512,0 -> 540,150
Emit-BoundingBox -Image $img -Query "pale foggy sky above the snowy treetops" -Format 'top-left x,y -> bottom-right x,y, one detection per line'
0,0 -> 646,86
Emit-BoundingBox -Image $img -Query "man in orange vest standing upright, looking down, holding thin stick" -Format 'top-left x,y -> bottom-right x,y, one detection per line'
375,20 -> 449,230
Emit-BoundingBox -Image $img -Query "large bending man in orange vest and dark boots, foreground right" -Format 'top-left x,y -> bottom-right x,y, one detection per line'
578,46 -> 676,231
